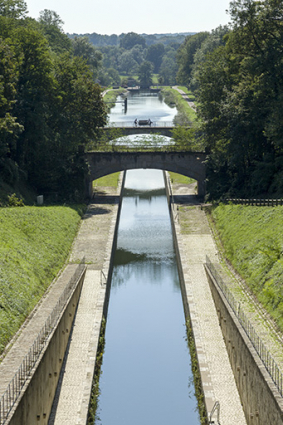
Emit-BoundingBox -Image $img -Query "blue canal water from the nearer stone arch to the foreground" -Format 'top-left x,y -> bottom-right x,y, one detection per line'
96,170 -> 200,425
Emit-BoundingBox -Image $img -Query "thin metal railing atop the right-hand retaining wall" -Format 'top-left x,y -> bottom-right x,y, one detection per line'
206,256 -> 283,396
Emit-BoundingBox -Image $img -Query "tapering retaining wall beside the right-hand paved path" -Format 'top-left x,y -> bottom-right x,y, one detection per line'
206,268 -> 283,425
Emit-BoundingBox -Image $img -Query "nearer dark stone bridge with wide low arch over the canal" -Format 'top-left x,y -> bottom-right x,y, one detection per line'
85,152 -> 206,197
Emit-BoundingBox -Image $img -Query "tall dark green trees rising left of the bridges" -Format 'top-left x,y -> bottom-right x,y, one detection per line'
0,0 -> 107,198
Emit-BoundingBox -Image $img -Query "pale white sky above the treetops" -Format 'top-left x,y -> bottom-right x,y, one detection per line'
26,0 -> 233,35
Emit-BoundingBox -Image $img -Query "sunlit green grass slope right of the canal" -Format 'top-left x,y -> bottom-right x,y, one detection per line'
212,205 -> 283,331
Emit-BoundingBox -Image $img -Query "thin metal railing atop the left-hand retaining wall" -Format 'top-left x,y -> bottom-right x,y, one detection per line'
0,258 -> 85,425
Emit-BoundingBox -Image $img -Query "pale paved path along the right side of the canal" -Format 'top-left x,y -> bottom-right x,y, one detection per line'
173,184 -> 246,425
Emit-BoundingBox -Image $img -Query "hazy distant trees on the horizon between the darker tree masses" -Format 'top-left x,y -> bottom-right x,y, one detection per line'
70,32 -> 185,86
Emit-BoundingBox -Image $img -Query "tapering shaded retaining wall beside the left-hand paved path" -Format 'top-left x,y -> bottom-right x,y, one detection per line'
7,270 -> 85,425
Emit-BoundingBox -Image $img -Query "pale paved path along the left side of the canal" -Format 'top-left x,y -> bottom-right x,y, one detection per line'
48,184 -> 120,425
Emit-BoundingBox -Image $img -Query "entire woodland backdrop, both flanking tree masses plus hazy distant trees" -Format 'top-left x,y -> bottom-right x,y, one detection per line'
0,0 -> 283,199
